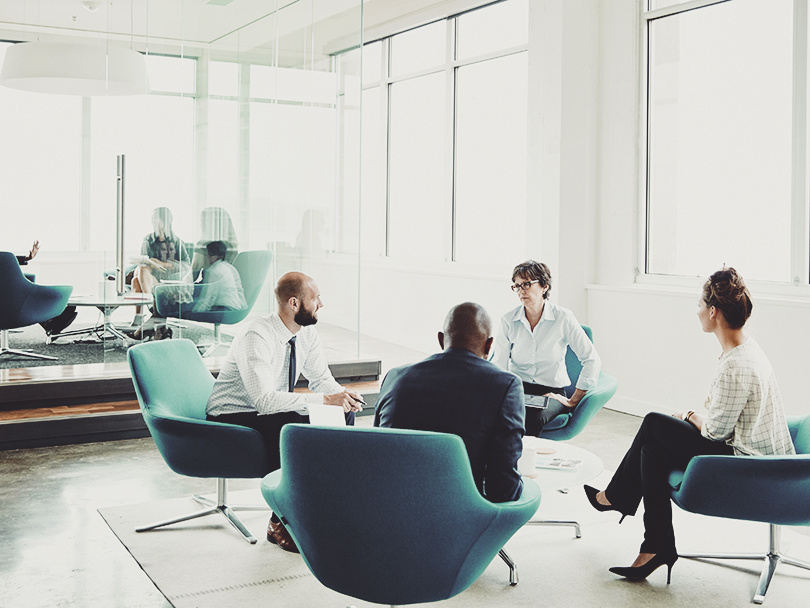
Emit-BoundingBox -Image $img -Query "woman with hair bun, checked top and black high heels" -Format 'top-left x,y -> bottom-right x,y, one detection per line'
585,267 -> 795,583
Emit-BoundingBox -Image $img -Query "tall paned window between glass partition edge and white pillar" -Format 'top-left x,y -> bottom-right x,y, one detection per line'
362,0 -> 528,270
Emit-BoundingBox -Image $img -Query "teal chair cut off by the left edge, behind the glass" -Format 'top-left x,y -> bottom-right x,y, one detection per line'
0,251 -> 73,329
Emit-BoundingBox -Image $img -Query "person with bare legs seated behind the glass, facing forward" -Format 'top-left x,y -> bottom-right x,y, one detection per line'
132,207 -> 189,327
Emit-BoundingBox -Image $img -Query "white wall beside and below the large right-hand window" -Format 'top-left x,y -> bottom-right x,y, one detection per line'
592,0 -> 810,414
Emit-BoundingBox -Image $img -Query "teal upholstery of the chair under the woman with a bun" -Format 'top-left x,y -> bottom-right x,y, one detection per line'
669,415 -> 810,526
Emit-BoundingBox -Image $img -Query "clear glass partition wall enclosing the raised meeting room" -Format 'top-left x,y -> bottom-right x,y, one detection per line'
0,0 -> 362,367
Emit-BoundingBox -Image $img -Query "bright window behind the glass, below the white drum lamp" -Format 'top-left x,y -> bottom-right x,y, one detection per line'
0,43 -> 196,252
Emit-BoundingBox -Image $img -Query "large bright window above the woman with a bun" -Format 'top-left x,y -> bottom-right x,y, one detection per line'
645,0 -> 792,282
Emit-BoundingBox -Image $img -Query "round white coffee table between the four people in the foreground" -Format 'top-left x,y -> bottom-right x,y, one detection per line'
523,437 -> 605,538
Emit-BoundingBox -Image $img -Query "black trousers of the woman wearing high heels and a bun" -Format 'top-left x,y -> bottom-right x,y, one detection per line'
605,412 -> 734,554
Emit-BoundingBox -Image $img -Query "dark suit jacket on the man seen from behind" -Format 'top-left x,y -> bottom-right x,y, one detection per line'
374,348 -> 524,502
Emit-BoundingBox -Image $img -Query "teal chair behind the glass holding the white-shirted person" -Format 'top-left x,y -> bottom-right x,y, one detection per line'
154,250 -> 273,325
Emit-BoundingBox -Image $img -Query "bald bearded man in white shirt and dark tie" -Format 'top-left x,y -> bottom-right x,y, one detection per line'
206,272 -> 363,553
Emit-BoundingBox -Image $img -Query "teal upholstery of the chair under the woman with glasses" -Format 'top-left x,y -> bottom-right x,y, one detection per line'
541,325 -> 619,441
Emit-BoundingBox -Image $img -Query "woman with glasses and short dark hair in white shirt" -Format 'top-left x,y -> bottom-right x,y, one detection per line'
492,260 -> 602,437
